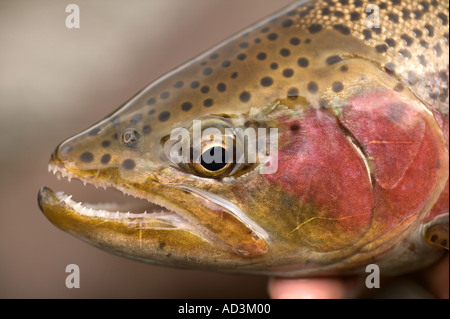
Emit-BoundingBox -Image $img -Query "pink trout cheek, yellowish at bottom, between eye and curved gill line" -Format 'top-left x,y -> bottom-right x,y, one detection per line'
265,108 -> 373,252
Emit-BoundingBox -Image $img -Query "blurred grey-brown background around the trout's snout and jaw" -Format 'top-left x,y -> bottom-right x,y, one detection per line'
0,0 -> 291,298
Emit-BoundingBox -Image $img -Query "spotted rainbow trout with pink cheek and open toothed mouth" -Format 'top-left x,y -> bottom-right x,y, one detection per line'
39,0 -> 448,276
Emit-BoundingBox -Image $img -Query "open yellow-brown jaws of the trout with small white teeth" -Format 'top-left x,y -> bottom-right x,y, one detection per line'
38,161 -> 268,270
